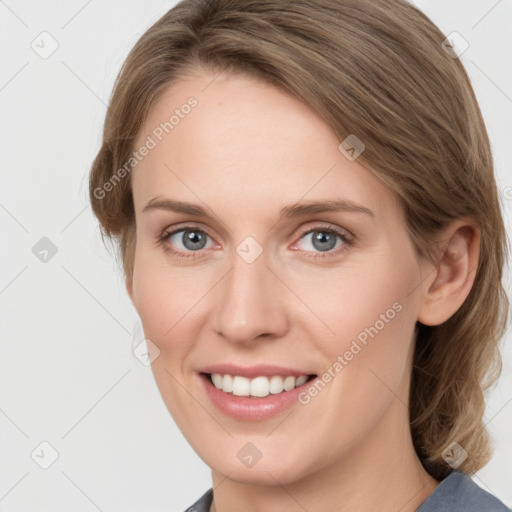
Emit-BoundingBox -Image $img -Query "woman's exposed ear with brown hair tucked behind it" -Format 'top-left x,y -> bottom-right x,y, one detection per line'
418,219 -> 480,325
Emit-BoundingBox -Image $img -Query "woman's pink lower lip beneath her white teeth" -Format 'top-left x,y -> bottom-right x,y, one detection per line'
199,374 -> 317,421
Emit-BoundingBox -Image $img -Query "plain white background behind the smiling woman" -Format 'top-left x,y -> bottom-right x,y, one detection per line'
0,0 -> 512,512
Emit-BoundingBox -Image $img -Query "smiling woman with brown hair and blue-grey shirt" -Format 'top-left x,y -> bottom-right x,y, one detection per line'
90,0 -> 508,512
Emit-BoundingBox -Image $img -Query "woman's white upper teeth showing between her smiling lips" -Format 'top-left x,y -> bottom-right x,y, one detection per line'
211,373 -> 308,398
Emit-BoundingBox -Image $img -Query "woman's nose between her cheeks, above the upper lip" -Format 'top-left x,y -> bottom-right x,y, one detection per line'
212,246 -> 289,345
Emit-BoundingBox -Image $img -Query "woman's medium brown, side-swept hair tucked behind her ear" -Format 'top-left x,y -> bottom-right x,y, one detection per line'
90,0 -> 508,480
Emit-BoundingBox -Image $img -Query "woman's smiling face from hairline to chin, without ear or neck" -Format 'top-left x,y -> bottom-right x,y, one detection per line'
127,68 -> 432,485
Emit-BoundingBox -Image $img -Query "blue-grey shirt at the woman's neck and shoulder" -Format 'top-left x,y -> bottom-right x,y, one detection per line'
185,471 -> 512,512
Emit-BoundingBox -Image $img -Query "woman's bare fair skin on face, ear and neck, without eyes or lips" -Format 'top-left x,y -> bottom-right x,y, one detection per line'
126,70 -> 479,512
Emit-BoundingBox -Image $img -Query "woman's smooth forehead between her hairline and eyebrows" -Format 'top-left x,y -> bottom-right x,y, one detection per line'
132,72 -> 396,222
